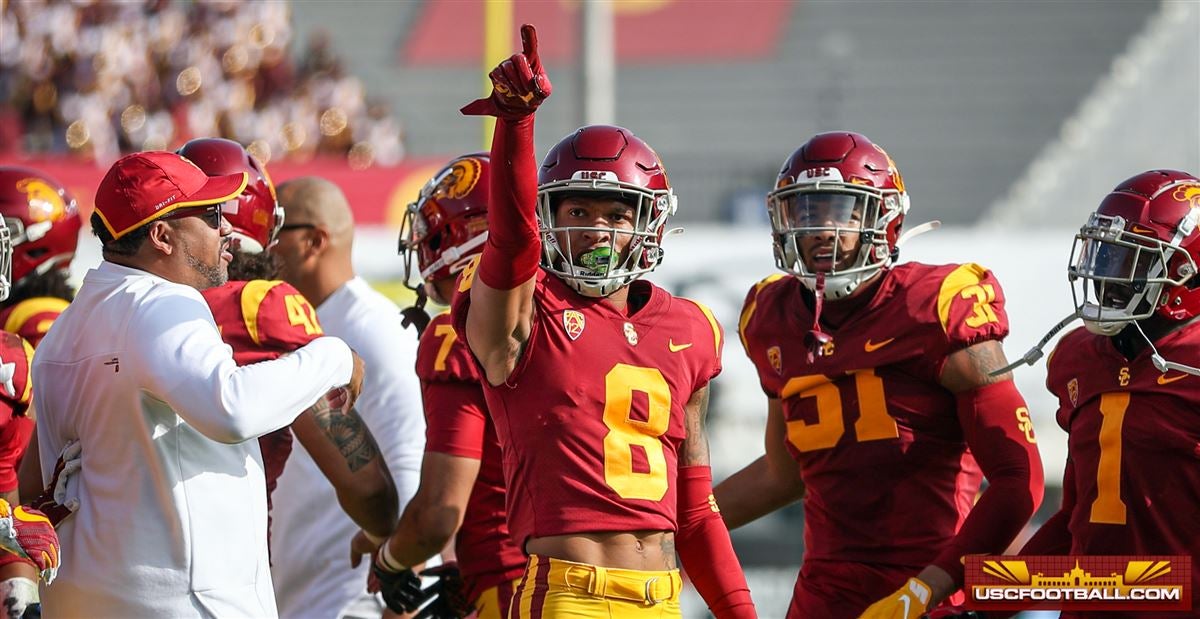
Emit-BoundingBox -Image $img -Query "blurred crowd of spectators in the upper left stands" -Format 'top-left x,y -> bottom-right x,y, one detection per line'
0,0 -> 404,168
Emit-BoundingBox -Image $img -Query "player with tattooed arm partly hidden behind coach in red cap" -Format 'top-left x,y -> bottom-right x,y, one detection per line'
179,138 -> 398,537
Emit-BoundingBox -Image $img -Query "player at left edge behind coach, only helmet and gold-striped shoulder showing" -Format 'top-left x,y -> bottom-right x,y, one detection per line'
0,166 -> 83,347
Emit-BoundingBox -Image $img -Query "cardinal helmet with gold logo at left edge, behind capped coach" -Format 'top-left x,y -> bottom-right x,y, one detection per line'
0,166 -> 83,293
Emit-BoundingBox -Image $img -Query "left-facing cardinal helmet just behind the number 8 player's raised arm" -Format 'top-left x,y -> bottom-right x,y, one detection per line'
400,152 -> 491,293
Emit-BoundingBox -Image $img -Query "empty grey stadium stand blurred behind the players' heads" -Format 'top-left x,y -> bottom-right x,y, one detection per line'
294,0 -> 1158,223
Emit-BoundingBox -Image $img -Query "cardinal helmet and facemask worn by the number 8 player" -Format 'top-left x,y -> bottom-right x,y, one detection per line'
538,125 -> 678,296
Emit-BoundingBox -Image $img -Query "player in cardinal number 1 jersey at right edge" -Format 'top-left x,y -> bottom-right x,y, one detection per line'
1021,170 -> 1200,617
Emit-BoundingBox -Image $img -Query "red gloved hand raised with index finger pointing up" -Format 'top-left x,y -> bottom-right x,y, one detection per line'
460,24 -> 553,120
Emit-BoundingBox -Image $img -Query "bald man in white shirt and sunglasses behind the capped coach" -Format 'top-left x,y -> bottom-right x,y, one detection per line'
271,176 -> 425,619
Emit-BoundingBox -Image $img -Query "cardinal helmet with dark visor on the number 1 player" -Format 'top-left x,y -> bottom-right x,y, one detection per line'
1067,170 -> 1200,336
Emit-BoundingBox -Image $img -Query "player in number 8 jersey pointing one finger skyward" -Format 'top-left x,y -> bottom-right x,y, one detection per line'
377,25 -> 755,618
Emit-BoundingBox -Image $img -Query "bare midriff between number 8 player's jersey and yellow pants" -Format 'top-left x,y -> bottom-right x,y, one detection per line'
526,531 -> 676,571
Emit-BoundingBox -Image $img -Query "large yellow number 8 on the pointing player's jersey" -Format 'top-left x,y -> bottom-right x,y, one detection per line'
604,363 -> 671,500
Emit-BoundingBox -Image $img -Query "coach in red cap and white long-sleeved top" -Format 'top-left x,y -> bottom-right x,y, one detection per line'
34,152 -> 362,618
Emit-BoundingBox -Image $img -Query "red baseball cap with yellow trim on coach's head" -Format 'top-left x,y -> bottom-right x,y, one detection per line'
96,151 -> 248,241
